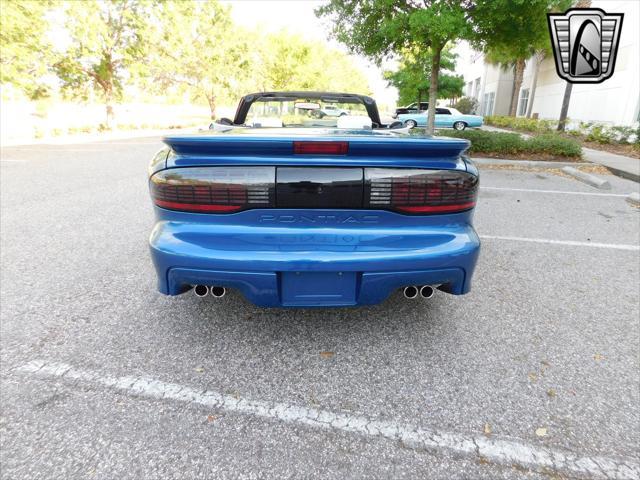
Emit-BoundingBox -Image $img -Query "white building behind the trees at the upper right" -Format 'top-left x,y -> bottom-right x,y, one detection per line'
456,0 -> 640,125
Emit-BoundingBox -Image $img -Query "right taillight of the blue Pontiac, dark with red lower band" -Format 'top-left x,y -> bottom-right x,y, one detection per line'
365,168 -> 478,214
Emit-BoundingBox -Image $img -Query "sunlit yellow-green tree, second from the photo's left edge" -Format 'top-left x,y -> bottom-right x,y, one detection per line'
54,0 -> 150,128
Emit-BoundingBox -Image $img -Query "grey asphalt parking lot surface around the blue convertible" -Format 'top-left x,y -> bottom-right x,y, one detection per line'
0,138 -> 640,479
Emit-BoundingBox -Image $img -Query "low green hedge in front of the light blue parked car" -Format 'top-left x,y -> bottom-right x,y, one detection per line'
440,130 -> 582,158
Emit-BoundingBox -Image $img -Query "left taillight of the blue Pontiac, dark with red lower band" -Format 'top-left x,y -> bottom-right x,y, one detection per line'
151,167 -> 275,213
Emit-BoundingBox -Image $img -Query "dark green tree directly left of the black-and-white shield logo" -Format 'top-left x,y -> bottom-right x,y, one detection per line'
474,0 -> 570,117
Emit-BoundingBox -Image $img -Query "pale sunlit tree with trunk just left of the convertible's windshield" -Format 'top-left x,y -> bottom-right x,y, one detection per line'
150,1 -> 252,120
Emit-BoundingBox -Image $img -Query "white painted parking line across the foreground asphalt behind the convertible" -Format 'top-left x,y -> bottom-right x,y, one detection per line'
15,360 -> 640,479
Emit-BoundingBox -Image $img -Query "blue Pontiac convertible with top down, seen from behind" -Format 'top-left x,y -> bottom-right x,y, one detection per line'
149,92 -> 480,307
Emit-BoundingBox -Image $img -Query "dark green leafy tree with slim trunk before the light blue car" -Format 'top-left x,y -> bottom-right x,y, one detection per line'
316,0 -> 472,134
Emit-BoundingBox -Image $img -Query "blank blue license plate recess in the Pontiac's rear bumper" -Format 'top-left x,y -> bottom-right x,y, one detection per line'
280,272 -> 358,307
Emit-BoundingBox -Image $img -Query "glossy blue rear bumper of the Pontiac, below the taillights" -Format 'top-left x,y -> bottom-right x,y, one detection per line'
150,214 -> 480,307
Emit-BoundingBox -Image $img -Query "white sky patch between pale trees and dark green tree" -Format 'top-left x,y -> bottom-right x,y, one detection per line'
220,0 -> 397,105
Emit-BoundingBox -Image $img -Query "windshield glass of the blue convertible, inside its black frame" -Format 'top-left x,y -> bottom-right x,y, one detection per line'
245,98 -> 371,128
